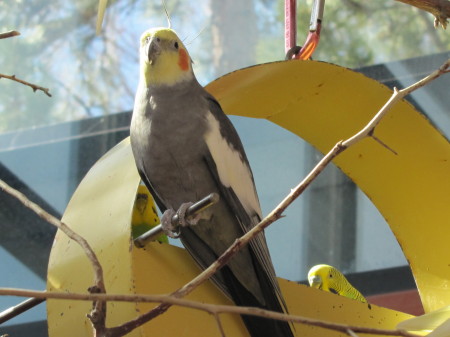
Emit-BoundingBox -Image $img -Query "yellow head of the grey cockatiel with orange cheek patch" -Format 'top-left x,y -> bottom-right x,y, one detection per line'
140,28 -> 194,87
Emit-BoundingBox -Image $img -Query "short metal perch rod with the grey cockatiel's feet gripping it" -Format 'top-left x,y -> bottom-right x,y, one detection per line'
134,193 -> 220,248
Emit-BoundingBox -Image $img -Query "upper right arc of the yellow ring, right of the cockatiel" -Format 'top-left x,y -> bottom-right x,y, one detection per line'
208,61 -> 450,312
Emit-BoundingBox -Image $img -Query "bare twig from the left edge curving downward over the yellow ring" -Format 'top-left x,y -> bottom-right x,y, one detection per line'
0,179 -> 106,326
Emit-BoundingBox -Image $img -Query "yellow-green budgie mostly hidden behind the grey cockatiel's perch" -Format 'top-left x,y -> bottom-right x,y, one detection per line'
131,185 -> 169,243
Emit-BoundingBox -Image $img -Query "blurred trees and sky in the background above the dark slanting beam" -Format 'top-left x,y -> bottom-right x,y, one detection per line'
0,0 -> 450,132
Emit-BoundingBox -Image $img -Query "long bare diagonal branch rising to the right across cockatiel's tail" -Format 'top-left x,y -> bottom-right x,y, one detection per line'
108,59 -> 450,337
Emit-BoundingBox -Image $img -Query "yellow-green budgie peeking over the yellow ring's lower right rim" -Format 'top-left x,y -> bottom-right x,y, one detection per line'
308,264 -> 370,308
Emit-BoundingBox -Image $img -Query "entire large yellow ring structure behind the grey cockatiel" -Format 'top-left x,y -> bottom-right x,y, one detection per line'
47,61 -> 450,337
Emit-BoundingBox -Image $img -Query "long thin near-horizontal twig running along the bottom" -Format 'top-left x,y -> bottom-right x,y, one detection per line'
0,288 -> 420,337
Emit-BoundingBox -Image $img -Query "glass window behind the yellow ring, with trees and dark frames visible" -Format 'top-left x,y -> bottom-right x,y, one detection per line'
0,0 -> 450,324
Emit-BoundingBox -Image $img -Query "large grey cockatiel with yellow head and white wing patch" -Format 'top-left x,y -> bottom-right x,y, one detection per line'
130,28 -> 293,337
